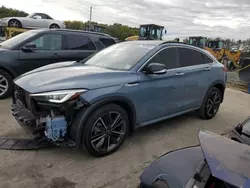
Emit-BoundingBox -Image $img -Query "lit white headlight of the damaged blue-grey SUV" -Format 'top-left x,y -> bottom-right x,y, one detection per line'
30,89 -> 87,103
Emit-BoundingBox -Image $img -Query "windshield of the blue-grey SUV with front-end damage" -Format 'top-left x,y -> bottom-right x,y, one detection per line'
84,42 -> 155,70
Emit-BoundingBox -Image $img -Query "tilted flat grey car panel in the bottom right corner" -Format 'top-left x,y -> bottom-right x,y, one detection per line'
198,131 -> 250,188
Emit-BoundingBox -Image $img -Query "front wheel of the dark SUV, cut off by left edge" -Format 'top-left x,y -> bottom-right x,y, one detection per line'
0,69 -> 12,100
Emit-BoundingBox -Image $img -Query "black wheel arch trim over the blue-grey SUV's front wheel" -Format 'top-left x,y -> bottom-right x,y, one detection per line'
73,96 -> 136,146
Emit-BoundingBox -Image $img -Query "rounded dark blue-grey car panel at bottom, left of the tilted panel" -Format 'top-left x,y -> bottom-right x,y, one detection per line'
140,146 -> 204,188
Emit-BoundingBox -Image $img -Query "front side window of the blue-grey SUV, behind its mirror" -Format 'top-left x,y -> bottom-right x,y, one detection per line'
146,48 -> 177,69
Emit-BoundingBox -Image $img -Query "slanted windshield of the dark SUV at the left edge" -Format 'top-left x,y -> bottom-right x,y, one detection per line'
0,30 -> 37,49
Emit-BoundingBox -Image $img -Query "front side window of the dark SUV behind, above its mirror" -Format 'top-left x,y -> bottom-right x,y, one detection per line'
27,34 -> 62,50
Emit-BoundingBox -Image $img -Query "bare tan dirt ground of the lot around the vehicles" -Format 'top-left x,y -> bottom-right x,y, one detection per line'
0,89 -> 250,188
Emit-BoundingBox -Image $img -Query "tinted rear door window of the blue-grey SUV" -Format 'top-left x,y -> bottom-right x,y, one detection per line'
178,48 -> 205,67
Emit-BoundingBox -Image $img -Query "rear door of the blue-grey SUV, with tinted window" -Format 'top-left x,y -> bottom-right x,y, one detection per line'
177,47 -> 213,110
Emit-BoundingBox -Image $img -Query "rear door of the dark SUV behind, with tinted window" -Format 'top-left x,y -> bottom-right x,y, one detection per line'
54,34 -> 97,61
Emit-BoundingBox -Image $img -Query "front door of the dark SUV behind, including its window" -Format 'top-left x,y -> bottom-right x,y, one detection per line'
18,33 -> 62,73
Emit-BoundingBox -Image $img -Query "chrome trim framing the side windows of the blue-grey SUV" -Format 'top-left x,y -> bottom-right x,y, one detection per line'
137,46 -> 216,72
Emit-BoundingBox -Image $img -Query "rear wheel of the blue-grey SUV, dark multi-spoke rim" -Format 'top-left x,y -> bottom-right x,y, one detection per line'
198,87 -> 222,119
